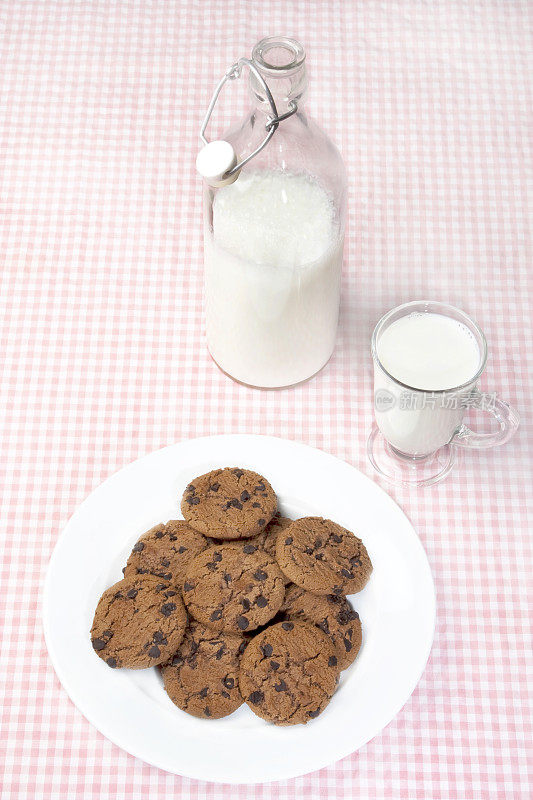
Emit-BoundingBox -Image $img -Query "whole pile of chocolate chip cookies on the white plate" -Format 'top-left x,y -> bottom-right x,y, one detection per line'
91,467 -> 372,725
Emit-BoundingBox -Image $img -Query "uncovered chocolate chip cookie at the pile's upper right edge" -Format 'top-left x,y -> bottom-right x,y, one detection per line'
276,517 -> 372,595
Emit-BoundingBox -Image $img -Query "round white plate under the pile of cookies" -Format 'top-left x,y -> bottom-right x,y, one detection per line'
44,435 -> 435,783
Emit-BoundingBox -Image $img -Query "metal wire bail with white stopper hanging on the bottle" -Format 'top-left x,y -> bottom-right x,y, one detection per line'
196,58 -> 298,186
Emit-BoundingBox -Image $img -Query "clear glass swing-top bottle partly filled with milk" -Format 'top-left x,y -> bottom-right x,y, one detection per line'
197,38 -> 346,388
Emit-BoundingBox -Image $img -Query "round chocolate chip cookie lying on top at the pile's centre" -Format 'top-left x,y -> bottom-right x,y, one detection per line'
183,542 -> 285,635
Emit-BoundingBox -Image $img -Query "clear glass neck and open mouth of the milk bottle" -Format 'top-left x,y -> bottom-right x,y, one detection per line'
250,36 -> 307,115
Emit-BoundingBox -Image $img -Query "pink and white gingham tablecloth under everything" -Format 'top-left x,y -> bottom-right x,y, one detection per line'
0,0 -> 533,800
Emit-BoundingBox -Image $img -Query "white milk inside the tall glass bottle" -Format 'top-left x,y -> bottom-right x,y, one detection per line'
205,170 -> 342,387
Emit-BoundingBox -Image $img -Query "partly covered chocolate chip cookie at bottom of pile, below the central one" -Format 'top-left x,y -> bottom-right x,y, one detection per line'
161,621 -> 246,719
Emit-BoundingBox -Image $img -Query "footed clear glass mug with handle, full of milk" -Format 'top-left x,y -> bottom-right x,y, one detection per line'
368,301 -> 519,486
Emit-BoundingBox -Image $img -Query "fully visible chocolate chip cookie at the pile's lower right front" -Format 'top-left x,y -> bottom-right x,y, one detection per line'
239,620 -> 339,725
